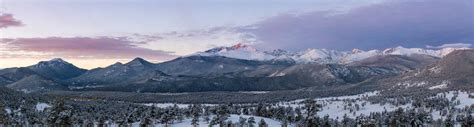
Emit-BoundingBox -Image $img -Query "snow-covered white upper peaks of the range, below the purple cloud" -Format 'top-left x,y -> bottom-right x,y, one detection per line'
193,43 -> 469,64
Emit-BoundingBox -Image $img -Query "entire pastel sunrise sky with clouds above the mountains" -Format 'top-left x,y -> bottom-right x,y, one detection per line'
0,0 -> 474,69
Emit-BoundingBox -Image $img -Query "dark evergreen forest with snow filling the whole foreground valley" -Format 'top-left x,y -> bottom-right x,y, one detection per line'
0,86 -> 474,127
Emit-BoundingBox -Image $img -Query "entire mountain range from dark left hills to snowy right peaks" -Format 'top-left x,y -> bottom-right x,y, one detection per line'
0,44 -> 474,92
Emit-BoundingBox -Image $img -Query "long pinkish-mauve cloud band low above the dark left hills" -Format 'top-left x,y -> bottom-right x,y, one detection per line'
0,37 -> 176,60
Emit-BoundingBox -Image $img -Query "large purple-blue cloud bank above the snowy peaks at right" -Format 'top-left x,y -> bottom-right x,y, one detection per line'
239,0 -> 474,50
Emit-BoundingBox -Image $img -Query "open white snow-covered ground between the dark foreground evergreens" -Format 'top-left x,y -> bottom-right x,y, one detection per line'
4,91 -> 474,127
